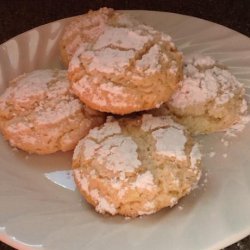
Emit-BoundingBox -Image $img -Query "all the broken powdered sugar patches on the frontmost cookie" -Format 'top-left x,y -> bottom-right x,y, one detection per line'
73,115 -> 201,216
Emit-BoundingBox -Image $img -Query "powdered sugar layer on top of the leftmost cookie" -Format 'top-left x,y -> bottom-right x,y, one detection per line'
0,70 -> 83,129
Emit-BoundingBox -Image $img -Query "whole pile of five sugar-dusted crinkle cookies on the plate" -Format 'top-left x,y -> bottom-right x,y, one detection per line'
0,8 -> 247,217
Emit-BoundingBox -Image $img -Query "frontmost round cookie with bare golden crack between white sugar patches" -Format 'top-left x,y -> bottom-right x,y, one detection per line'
73,114 -> 201,217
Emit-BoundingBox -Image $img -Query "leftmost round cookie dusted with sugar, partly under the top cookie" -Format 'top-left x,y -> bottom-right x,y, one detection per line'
0,70 -> 105,154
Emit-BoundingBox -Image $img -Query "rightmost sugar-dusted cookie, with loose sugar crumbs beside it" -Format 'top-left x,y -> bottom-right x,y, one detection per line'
166,56 -> 247,134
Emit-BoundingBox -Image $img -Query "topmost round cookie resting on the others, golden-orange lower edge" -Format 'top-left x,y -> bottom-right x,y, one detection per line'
68,22 -> 182,115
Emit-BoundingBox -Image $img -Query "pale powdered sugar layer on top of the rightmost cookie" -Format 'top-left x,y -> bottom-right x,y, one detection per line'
170,56 -> 243,108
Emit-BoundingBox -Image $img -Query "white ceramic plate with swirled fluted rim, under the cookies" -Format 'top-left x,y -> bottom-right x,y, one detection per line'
0,11 -> 250,250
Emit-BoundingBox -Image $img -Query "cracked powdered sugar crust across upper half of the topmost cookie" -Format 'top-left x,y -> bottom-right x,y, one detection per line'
69,25 -> 172,74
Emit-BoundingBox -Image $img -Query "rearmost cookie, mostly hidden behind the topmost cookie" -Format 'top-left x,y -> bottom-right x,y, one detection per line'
60,7 -> 140,66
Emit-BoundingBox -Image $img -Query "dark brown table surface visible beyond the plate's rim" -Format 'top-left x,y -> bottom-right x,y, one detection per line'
0,0 -> 250,250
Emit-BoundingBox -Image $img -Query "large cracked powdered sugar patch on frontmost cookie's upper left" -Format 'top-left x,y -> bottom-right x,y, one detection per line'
81,121 -> 141,173
